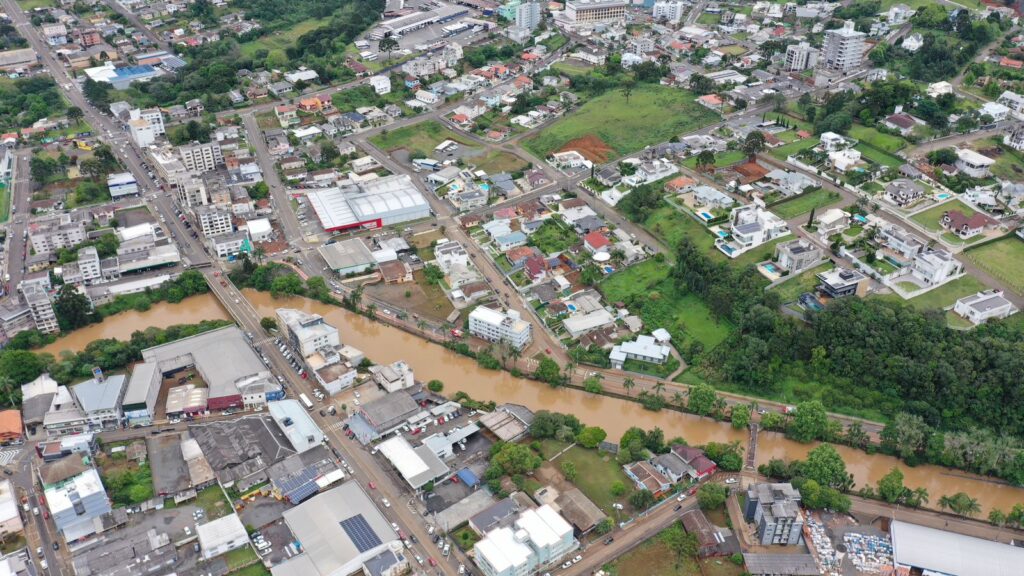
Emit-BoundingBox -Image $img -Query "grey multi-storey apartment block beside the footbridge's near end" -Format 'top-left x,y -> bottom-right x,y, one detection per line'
743,483 -> 804,546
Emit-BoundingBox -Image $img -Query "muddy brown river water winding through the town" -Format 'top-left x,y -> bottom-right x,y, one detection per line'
36,290 -> 1024,515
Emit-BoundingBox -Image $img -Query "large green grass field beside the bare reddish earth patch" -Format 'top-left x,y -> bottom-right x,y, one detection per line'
523,85 -> 718,160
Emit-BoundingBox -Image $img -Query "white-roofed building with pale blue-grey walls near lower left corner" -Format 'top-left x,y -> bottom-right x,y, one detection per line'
44,457 -> 111,543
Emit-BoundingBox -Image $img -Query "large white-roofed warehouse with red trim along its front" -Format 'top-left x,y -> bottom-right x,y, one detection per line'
306,174 -> 430,232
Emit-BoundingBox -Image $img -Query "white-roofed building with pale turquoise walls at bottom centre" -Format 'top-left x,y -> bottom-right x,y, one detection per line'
473,504 -> 578,576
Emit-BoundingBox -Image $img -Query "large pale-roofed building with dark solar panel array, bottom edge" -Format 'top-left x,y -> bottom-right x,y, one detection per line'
270,482 -> 409,576
